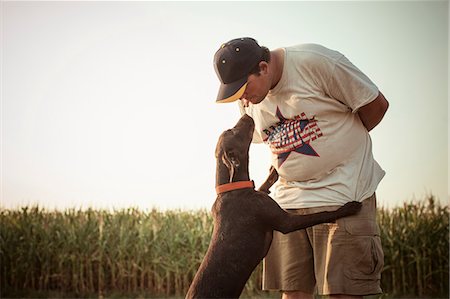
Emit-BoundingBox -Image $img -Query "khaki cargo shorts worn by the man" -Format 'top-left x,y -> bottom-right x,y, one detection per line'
263,194 -> 384,295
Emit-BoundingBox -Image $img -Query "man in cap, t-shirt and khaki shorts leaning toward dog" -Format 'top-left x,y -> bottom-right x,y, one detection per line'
214,38 -> 389,298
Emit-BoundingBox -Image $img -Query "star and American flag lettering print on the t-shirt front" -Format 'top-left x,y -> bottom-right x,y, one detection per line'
264,107 -> 323,167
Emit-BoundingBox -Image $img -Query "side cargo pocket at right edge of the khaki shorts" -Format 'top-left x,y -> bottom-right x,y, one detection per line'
344,219 -> 384,280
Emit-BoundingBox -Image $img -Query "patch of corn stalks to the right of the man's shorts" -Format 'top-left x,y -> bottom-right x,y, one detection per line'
378,196 -> 449,298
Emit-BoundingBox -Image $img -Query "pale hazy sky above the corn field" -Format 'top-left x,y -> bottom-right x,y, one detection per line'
0,1 -> 449,209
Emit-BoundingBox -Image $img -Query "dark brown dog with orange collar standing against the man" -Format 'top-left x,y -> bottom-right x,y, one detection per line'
186,114 -> 361,298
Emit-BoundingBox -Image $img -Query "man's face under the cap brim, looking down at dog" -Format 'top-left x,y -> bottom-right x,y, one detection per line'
240,65 -> 270,107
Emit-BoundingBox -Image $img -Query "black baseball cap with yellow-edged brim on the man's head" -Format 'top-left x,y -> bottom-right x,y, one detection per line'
214,37 -> 264,103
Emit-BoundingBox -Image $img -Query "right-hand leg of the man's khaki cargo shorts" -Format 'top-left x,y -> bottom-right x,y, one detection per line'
307,194 -> 383,299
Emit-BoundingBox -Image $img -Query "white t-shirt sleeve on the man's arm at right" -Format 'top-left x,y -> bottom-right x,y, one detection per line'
326,55 -> 379,113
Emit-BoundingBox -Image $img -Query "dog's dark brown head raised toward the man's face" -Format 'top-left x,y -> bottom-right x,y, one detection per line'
216,114 -> 255,179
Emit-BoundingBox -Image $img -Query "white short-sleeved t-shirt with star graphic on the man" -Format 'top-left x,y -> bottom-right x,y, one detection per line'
239,44 -> 385,209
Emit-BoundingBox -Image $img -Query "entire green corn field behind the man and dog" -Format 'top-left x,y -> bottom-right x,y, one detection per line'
0,197 -> 449,298
